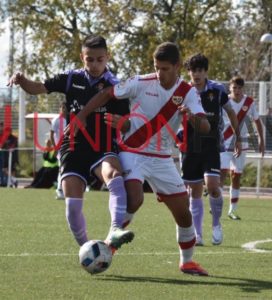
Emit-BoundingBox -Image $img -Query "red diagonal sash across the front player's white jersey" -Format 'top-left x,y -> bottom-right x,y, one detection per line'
125,81 -> 192,148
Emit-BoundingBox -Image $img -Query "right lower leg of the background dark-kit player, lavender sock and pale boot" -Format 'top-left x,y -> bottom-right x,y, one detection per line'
205,175 -> 223,245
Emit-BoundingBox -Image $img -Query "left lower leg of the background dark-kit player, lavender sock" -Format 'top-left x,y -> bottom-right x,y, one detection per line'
189,180 -> 204,246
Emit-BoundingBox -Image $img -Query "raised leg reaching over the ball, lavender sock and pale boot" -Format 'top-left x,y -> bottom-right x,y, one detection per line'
94,156 -> 134,249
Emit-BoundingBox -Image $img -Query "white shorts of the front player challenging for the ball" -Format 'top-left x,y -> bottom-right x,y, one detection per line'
119,152 -> 187,200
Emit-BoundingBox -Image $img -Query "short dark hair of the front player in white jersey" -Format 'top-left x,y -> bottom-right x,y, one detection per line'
153,42 -> 180,65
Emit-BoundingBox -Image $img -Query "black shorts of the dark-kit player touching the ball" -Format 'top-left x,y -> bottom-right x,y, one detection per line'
60,136 -> 118,185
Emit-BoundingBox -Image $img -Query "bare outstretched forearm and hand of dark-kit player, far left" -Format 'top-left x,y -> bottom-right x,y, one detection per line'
7,72 -> 47,95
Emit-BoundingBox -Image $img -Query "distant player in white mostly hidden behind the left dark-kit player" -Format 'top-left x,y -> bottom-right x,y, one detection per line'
50,102 -> 66,200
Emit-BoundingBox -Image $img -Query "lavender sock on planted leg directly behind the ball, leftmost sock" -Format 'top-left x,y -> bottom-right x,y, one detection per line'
65,198 -> 88,246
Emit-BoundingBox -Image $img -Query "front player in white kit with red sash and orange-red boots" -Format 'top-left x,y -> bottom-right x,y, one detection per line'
73,42 -> 210,275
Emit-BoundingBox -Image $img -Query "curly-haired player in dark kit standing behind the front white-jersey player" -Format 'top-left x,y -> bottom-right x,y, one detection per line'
182,54 -> 240,246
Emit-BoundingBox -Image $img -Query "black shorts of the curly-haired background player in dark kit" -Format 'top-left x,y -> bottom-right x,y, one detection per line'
182,151 -> 220,182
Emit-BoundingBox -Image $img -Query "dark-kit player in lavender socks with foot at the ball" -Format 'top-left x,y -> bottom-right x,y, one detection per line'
8,36 -> 134,249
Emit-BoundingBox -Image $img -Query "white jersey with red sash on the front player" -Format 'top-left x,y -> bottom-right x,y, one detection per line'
113,73 -> 204,157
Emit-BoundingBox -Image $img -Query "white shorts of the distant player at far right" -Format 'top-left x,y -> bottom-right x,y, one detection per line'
220,151 -> 246,174
